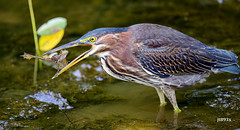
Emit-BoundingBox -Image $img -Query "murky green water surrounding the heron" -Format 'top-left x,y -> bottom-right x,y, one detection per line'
0,0 -> 240,129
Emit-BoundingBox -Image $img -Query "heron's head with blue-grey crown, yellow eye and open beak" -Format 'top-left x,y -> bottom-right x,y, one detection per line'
43,27 -> 128,78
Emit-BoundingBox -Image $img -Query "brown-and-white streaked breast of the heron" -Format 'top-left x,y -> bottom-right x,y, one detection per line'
100,56 -> 161,87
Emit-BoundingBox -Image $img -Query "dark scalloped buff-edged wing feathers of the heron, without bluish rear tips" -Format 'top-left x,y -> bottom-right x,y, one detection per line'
135,45 -> 216,77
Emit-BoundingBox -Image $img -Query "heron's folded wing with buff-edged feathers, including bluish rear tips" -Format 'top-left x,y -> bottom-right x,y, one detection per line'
134,38 -> 236,77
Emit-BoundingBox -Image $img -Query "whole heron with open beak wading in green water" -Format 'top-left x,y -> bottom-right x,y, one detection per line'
44,24 -> 240,112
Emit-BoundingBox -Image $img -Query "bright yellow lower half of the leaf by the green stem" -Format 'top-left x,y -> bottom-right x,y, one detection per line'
39,29 -> 64,51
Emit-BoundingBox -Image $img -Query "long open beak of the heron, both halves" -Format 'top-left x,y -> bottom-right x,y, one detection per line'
43,40 -> 92,79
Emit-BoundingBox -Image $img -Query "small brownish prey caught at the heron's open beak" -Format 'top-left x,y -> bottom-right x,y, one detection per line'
21,50 -> 68,70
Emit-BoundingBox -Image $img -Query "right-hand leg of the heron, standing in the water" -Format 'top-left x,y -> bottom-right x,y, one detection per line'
162,86 -> 181,113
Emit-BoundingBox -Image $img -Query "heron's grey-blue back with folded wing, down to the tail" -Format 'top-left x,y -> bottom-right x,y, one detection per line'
130,24 -> 240,77
